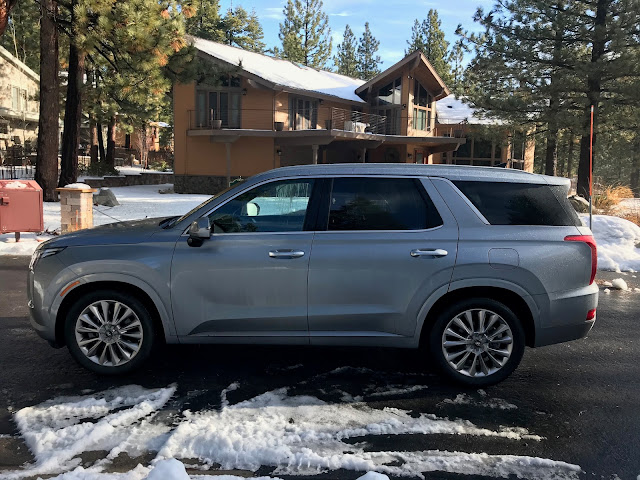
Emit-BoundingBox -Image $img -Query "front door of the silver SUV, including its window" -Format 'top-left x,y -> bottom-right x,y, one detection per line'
171,179 -> 314,343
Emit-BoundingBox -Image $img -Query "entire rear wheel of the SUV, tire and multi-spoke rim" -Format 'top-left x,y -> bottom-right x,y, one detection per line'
429,298 -> 525,386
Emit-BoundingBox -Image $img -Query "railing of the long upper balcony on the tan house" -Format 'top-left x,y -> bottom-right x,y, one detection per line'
188,105 -> 390,135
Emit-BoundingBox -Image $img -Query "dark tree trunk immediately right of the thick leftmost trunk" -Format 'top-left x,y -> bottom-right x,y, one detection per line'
58,40 -> 85,187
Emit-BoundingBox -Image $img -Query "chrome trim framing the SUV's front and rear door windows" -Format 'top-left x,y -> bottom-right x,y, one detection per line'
181,174 -> 450,237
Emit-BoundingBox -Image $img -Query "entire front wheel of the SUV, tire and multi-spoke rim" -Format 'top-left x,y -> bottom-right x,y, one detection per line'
65,290 -> 154,375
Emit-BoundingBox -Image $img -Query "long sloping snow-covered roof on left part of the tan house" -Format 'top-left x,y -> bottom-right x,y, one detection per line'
190,37 -> 365,103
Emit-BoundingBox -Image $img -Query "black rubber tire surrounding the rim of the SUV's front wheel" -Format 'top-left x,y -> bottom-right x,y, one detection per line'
64,290 -> 156,375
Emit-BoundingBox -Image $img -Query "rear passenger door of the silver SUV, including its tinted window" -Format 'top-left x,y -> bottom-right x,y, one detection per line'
308,176 -> 458,344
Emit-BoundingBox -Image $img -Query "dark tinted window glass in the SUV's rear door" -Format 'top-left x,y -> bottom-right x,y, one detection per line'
327,177 -> 442,231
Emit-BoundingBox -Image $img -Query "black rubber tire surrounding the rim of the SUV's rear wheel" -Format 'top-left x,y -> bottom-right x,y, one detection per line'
429,298 -> 525,387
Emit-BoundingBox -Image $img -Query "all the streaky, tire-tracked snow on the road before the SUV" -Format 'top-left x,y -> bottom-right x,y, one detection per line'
0,369 -> 581,480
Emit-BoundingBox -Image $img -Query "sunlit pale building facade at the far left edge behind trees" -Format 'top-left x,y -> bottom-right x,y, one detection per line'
0,47 -> 39,150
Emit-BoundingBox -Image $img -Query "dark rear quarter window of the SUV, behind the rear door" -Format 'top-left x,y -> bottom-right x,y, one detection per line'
453,181 -> 582,226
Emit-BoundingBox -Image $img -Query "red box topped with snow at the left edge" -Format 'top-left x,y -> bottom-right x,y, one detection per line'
0,180 -> 44,240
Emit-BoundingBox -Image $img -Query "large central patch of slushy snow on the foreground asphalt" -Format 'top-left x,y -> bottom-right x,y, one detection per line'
158,388 -> 542,476
